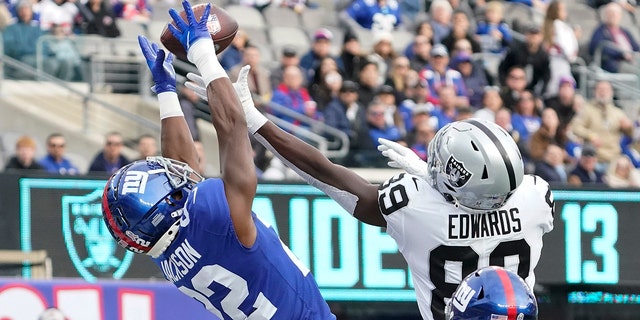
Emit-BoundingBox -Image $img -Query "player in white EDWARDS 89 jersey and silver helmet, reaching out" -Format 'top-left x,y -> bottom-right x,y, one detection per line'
187,74 -> 554,320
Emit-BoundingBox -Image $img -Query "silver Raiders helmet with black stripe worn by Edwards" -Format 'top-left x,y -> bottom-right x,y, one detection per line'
427,118 -> 524,212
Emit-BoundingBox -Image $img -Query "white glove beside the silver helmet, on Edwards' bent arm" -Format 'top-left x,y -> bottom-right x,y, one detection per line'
378,138 -> 429,178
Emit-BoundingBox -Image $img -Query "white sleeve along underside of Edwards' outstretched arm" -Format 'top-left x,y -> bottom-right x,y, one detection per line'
254,133 -> 358,215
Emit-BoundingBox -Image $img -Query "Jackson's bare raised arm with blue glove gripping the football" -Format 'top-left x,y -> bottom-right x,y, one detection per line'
169,0 -> 257,246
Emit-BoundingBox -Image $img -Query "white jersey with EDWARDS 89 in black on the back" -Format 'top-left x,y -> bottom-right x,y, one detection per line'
378,173 -> 553,320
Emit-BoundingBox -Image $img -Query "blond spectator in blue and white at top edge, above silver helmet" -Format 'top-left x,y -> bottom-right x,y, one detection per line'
476,1 -> 512,53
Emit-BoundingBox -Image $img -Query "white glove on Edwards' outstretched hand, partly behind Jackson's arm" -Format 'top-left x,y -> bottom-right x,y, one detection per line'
185,65 -> 267,134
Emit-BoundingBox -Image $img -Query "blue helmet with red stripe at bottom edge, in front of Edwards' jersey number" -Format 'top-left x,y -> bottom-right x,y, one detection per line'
445,266 -> 538,320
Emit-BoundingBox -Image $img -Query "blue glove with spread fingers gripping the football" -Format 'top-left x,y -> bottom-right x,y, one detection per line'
169,0 -> 211,52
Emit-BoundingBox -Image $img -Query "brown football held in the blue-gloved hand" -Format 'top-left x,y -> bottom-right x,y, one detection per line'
160,3 -> 238,60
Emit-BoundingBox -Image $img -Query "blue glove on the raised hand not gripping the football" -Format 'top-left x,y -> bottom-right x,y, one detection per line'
138,36 -> 176,93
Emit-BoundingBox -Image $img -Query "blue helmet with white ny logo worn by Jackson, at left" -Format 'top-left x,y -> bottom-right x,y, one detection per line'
102,157 -> 204,258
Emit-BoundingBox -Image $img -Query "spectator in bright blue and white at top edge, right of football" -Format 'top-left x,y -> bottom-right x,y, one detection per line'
341,0 -> 401,32
